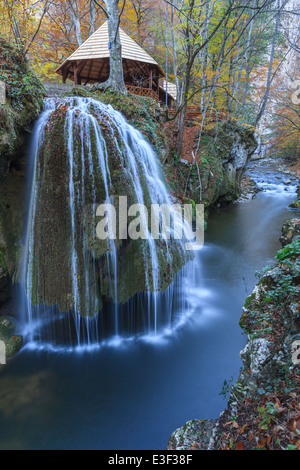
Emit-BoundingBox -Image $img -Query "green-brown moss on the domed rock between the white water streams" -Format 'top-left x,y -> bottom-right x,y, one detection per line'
25,90 -> 186,316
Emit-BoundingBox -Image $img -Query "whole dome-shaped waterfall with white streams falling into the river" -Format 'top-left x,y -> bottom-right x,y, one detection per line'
21,97 -> 192,346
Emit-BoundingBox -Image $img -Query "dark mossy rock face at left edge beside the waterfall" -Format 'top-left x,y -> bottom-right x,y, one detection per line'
0,38 -> 43,305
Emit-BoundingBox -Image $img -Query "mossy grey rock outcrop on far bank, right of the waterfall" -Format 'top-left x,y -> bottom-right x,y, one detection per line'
167,123 -> 257,208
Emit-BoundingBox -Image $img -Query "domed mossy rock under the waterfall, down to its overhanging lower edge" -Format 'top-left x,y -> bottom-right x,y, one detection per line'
25,97 -> 190,316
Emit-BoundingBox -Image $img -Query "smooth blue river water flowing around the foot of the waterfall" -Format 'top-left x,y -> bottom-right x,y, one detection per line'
0,163 -> 299,450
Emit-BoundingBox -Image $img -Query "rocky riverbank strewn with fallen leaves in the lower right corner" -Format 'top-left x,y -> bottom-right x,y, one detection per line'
167,219 -> 300,450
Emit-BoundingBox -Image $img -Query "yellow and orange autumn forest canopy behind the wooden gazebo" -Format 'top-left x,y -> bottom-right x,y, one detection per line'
0,0 -> 299,158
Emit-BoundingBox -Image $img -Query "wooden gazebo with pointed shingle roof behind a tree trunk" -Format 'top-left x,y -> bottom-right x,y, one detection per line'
56,21 -> 174,104
